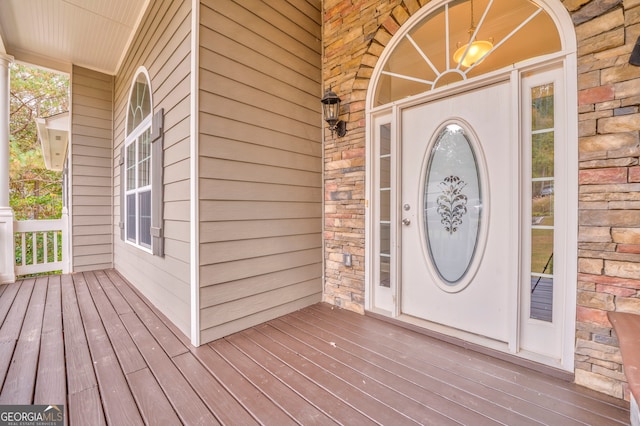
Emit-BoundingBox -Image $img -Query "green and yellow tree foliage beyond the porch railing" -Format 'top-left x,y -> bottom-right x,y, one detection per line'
9,64 -> 69,220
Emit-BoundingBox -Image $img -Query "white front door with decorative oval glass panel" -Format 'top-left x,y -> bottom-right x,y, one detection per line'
399,80 -> 519,342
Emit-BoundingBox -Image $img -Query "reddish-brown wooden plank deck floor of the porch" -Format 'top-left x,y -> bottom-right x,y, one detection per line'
0,270 -> 629,425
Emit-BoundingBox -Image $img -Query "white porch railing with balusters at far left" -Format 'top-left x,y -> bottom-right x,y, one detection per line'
13,214 -> 69,275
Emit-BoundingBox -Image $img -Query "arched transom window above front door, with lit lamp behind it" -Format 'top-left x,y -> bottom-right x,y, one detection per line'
373,0 -> 562,106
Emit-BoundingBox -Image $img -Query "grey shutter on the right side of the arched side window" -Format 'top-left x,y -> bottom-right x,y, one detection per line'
151,108 -> 164,256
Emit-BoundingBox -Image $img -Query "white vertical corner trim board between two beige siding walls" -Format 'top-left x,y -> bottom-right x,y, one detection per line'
189,0 -> 200,346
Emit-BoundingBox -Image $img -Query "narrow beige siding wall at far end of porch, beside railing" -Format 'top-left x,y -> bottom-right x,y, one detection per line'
70,66 -> 113,272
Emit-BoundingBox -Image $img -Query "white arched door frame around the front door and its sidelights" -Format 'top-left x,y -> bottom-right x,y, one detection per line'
365,0 -> 578,371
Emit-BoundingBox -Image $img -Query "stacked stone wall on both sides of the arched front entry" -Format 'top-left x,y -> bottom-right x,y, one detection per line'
323,0 -> 640,399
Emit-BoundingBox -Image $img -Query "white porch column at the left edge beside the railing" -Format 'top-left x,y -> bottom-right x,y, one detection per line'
0,53 -> 16,284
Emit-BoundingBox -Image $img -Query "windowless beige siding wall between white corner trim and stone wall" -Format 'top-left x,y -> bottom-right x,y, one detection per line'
199,0 -> 323,342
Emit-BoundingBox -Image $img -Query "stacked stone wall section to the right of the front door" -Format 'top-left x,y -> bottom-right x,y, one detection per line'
564,0 -> 640,399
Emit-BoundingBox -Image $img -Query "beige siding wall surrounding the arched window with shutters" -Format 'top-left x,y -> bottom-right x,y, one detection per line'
111,0 -> 191,335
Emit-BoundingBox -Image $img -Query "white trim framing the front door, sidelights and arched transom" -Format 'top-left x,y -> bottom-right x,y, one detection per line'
365,0 -> 578,371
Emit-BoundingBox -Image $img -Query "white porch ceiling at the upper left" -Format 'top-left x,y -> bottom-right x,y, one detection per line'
0,0 -> 149,74
